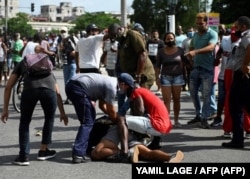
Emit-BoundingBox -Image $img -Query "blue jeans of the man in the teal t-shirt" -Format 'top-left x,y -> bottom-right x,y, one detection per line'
190,67 -> 214,119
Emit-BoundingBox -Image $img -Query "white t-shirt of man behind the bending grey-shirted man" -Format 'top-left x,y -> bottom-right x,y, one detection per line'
75,34 -> 104,69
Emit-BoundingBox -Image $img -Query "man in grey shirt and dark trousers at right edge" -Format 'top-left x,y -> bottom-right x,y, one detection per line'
222,16 -> 250,148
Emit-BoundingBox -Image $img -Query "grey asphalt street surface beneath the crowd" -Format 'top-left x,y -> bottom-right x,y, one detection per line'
0,70 -> 250,179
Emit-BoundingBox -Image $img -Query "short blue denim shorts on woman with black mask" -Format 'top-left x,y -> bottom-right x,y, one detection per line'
161,75 -> 185,86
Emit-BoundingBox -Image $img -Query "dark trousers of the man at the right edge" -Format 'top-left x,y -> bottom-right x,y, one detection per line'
229,71 -> 250,144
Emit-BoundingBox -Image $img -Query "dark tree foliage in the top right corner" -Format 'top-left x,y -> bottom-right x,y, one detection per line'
211,0 -> 250,24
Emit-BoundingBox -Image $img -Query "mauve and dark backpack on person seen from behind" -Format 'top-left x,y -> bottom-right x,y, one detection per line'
24,53 -> 53,77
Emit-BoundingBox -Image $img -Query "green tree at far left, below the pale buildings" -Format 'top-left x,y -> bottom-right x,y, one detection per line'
1,13 -> 35,36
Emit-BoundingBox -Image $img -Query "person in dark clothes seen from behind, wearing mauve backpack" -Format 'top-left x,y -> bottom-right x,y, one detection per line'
1,45 -> 68,166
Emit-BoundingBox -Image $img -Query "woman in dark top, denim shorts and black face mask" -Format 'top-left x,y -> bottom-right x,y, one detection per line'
155,32 -> 186,128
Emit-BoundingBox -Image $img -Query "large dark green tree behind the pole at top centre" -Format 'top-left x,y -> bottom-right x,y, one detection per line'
130,0 -> 200,35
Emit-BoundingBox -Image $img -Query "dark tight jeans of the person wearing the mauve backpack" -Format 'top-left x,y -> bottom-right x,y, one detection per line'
19,88 -> 57,156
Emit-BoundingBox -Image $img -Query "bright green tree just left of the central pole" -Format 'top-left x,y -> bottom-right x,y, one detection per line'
73,12 -> 120,31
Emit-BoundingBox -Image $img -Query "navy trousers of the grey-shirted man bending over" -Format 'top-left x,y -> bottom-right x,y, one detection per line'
65,80 -> 96,156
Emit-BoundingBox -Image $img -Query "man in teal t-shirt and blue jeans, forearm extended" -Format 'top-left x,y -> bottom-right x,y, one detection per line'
185,13 -> 218,129
